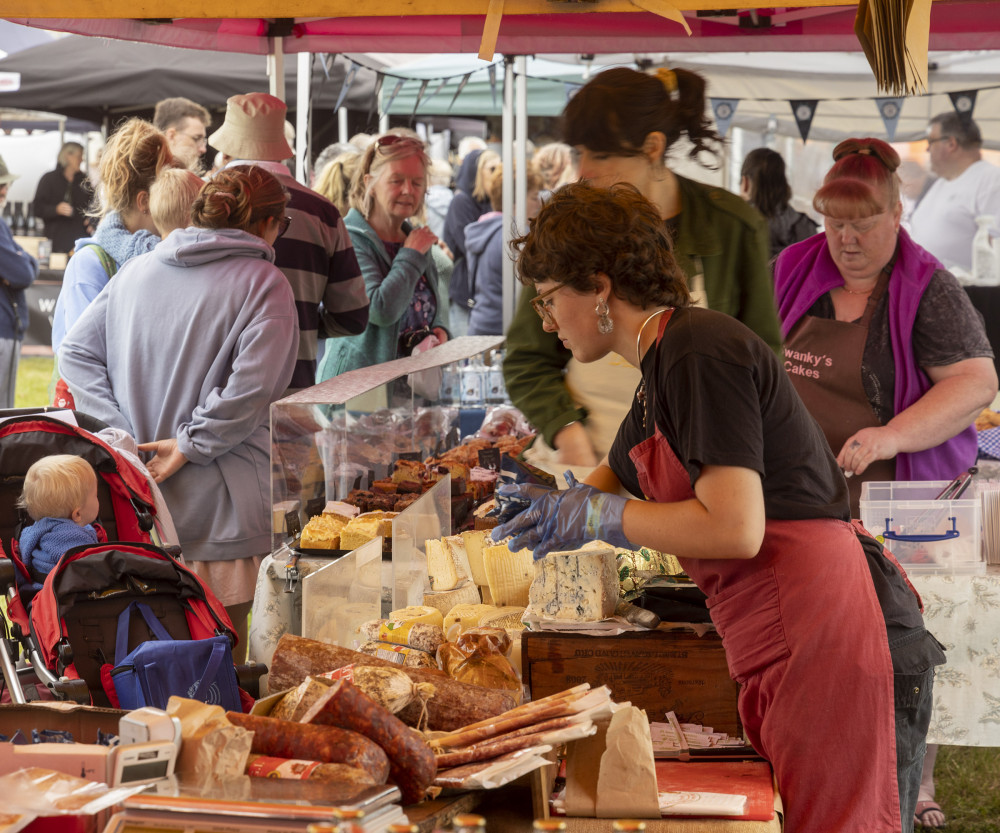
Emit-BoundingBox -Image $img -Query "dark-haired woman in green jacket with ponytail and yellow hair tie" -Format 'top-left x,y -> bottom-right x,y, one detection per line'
504,67 -> 781,474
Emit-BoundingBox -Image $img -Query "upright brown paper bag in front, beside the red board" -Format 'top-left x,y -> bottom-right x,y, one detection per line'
594,706 -> 660,819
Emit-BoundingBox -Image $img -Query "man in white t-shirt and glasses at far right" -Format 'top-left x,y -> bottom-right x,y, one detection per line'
910,111 -> 1000,272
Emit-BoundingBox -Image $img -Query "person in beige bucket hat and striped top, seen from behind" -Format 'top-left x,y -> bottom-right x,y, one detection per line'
208,93 -> 368,394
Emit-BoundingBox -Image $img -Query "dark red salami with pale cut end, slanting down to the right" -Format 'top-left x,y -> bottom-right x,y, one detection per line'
302,680 -> 437,804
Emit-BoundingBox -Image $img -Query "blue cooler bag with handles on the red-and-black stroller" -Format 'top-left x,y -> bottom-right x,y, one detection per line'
111,602 -> 242,712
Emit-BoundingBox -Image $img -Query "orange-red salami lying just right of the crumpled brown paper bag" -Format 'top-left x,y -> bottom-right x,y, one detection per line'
226,712 -> 389,784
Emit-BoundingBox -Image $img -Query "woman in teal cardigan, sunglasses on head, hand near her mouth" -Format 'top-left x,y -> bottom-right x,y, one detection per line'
317,133 -> 448,382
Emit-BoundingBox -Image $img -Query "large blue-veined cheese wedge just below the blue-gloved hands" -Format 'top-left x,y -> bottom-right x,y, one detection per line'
526,546 -> 619,622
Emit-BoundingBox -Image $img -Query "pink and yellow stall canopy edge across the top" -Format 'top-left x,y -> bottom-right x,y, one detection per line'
3,0 -> 1000,55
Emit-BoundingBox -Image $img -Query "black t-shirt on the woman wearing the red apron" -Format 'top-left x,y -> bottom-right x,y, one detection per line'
608,308 -> 850,520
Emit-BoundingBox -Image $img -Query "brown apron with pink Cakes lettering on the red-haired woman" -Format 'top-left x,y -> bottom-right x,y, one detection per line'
784,271 -> 896,518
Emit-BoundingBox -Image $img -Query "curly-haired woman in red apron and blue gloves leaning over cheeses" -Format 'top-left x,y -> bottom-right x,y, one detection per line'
500,183 -> 940,833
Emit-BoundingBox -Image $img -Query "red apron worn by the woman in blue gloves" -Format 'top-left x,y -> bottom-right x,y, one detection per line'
629,314 -> 901,833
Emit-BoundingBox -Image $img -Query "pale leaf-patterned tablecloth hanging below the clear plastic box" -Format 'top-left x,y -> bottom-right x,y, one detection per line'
910,566 -> 1000,747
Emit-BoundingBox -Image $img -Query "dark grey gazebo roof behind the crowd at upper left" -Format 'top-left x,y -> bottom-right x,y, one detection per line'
0,36 -> 374,124
